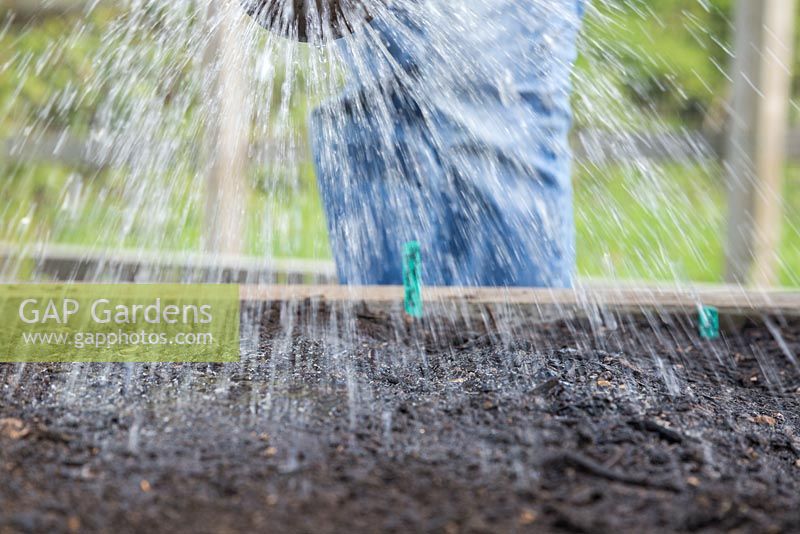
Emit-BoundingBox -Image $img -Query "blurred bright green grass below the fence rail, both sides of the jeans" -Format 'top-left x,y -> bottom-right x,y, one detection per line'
6,157 -> 800,286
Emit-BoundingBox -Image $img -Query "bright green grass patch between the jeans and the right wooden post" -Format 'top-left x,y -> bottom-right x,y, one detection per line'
575,161 -> 725,282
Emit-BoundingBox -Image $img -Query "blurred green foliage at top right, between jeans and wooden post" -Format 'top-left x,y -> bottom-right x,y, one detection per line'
589,0 -> 800,126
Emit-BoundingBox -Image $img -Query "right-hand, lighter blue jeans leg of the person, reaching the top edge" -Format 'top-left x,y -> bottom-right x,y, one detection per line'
422,0 -> 583,287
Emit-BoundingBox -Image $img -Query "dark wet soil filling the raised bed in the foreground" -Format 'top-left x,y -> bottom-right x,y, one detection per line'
0,303 -> 800,533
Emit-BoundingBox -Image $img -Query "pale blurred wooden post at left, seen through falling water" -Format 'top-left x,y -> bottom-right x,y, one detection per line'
203,0 -> 250,255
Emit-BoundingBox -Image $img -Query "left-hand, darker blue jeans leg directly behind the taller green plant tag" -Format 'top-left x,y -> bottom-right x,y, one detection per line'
315,108 -> 453,285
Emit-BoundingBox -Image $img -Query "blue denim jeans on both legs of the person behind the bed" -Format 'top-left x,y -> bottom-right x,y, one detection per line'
311,0 -> 583,287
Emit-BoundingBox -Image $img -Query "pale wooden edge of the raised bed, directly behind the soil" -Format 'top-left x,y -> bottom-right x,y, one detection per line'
240,284 -> 800,315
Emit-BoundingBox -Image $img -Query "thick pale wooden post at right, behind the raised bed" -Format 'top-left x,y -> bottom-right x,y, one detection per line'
725,0 -> 795,286
